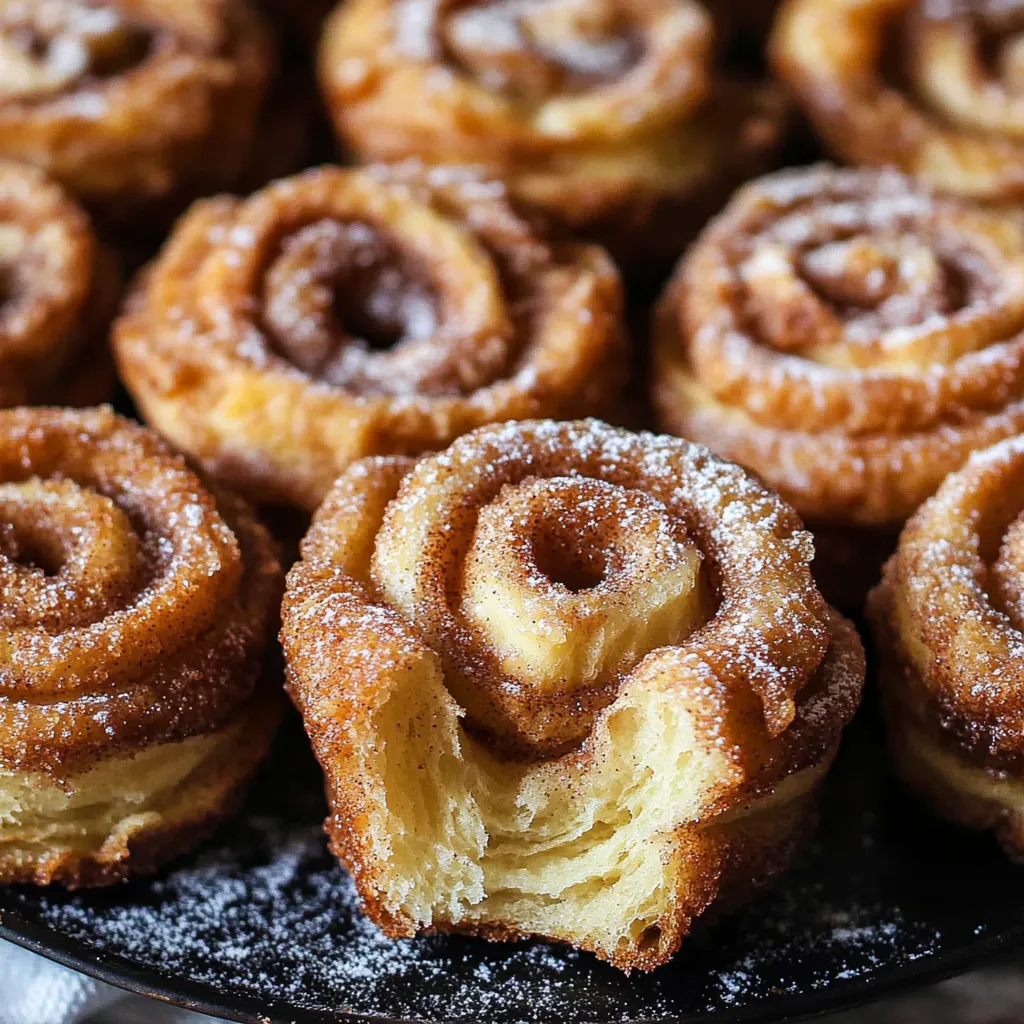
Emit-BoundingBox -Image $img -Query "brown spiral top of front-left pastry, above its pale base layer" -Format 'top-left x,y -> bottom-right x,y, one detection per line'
0,409 -> 281,773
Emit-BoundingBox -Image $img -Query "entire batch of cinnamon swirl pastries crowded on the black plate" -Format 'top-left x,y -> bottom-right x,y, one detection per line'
8,0 -> 1024,970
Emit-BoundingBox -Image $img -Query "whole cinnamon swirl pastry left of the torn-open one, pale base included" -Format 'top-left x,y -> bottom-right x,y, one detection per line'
0,409 -> 282,886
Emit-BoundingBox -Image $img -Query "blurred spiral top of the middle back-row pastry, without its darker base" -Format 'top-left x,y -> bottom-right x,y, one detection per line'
322,0 -> 711,155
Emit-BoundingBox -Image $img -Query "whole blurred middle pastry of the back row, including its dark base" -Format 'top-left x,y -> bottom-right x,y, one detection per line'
319,0 -> 784,260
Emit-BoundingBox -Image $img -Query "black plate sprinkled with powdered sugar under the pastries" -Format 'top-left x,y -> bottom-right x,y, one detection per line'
0,711 -> 1024,1024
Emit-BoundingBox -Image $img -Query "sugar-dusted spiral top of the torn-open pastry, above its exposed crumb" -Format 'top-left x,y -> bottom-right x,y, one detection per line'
284,421 -> 859,758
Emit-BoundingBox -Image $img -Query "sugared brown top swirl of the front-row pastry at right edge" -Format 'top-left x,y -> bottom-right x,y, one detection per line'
870,437 -> 1024,774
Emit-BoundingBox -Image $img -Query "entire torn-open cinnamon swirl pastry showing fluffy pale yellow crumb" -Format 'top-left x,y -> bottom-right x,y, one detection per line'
282,420 -> 864,970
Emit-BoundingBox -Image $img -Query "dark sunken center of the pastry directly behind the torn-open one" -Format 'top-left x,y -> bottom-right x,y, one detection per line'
263,219 -> 438,386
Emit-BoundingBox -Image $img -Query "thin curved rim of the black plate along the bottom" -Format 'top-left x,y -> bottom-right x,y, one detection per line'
0,906 -> 1024,1024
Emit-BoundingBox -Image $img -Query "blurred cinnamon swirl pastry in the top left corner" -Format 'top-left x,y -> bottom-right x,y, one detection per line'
0,0 -> 270,219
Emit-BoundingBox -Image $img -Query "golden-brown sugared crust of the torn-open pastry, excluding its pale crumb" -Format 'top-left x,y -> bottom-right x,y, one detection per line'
282,421 -> 864,969
